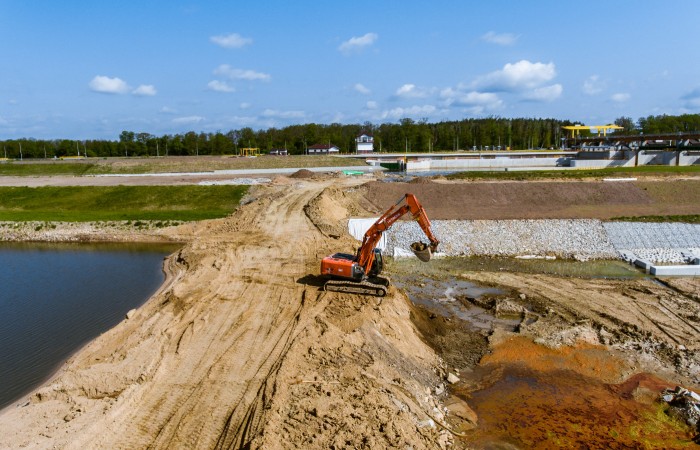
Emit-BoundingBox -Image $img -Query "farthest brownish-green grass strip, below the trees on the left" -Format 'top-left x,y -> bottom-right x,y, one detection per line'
0,156 -> 364,176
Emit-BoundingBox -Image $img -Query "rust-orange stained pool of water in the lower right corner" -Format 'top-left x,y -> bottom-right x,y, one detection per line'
456,338 -> 695,449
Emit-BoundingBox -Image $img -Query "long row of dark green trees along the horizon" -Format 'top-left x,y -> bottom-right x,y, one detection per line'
0,114 -> 700,158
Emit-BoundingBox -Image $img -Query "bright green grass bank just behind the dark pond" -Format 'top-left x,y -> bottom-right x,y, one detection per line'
0,186 -> 248,222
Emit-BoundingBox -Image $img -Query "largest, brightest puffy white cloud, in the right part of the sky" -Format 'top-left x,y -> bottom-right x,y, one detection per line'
474,60 -> 557,92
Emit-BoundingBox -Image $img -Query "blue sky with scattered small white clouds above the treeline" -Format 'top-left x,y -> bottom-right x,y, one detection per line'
0,0 -> 700,139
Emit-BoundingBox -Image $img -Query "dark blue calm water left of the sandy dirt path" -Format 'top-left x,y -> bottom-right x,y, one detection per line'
0,243 -> 177,409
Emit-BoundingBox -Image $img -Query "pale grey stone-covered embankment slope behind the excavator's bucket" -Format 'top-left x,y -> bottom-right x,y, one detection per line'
386,219 -> 700,263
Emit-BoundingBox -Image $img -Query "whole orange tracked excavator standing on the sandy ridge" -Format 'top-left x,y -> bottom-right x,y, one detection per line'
321,194 -> 440,297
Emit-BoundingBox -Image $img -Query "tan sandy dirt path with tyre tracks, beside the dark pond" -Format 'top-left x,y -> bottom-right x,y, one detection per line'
0,180 -> 448,448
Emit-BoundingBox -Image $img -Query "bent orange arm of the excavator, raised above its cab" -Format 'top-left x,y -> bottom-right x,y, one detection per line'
357,194 -> 440,274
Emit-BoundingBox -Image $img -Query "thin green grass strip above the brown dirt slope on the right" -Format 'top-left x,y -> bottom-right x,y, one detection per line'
447,166 -> 700,180
